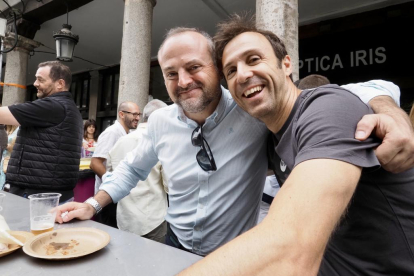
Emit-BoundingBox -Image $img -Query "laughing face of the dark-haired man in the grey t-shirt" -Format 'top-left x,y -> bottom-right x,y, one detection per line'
222,32 -> 292,125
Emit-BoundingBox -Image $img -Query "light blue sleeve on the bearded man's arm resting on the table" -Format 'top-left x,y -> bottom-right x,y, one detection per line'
99,123 -> 158,203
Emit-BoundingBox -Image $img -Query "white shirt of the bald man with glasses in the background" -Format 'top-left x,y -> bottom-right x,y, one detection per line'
92,121 -> 127,193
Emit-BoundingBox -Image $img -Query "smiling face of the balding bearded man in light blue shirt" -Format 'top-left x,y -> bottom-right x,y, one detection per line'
158,32 -> 221,118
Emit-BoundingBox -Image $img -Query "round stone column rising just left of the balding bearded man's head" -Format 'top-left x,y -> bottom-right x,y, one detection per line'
118,0 -> 157,112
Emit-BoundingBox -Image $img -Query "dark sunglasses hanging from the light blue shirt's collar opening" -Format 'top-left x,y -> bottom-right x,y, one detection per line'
191,126 -> 217,172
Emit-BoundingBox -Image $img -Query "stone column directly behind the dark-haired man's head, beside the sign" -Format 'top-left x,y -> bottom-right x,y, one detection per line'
256,0 -> 299,81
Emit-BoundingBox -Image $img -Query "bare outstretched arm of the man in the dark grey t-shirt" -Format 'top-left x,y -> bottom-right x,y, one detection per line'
180,159 -> 361,275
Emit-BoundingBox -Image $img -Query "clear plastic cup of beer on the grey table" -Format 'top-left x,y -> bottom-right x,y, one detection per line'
29,193 -> 62,235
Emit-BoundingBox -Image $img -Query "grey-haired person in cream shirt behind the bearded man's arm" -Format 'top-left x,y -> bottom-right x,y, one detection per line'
108,100 -> 168,243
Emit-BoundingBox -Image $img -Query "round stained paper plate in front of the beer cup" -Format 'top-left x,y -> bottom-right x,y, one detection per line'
23,228 -> 110,260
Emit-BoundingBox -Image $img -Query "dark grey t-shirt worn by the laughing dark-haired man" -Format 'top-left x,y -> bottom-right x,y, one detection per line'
269,85 -> 414,276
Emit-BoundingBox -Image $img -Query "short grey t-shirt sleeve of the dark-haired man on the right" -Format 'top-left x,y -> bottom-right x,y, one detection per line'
294,87 -> 379,169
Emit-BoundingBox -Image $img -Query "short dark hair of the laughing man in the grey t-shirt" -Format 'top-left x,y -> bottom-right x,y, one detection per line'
213,14 -> 288,70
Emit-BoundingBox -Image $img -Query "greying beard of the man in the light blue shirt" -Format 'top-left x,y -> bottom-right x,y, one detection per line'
175,82 -> 219,113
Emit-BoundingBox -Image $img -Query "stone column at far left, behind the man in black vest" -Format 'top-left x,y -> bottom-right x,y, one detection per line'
2,33 -> 41,106
